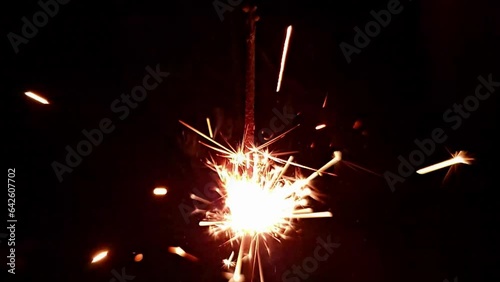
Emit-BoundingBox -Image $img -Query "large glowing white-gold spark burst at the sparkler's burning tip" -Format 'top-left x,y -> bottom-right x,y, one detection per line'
180,121 -> 341,281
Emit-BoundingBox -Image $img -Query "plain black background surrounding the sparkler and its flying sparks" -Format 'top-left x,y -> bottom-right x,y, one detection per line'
0,0 -> 500,282
